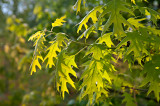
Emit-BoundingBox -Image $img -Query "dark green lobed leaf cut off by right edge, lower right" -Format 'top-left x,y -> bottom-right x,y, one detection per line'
140,55 -> 160,101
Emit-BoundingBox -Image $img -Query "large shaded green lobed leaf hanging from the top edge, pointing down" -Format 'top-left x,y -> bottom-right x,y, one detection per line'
102,0 -> 134,35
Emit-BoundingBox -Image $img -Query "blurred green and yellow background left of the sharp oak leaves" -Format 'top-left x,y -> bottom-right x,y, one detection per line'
0,0 -> 160,106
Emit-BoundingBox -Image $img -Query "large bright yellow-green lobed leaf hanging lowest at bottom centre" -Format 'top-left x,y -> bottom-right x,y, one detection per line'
80,60 -> 111,104
